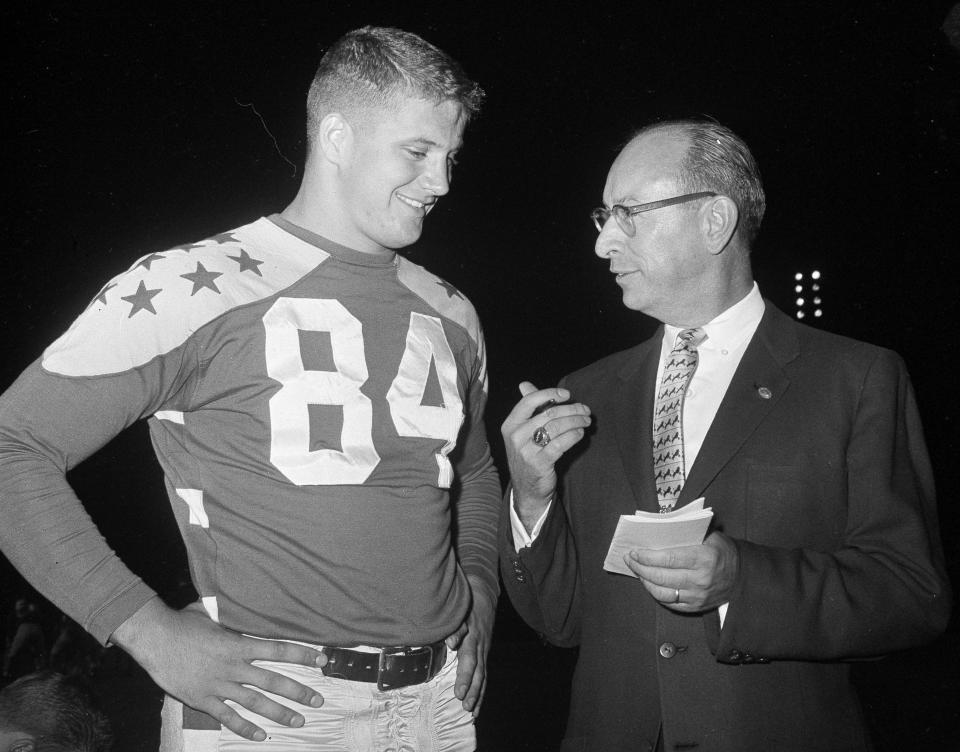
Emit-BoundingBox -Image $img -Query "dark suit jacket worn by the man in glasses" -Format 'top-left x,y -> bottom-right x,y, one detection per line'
500,302 -> 950,752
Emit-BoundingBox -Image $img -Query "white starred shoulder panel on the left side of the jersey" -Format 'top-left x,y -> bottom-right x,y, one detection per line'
43,218 -> 330,376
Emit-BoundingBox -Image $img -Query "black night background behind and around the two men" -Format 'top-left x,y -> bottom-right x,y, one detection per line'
0,1 -> 960,750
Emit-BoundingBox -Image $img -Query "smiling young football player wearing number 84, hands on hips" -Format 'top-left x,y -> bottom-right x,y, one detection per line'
0,27 -> 500,751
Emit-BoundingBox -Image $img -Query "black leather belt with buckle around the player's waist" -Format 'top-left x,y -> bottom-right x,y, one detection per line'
321,640 -> 447,691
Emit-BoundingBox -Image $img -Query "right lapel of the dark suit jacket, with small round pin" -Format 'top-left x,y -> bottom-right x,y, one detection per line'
677,301 -> 799,506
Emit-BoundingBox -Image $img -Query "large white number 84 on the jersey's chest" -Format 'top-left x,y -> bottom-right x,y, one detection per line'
263,298 -> 463,488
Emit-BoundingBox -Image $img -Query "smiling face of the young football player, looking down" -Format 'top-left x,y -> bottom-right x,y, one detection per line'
341,99 -> 464,253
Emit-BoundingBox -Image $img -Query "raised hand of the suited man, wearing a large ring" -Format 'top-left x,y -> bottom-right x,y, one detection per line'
500,381 -> 591,512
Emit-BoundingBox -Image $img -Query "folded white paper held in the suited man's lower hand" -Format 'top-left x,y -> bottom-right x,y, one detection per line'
603,497 -> 713,577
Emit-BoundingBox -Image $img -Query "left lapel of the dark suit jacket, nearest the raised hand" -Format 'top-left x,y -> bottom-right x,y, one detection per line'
610,326 -> 663,513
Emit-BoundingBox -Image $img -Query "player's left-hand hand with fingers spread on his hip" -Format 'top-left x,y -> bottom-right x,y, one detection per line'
111,598 -> 327,741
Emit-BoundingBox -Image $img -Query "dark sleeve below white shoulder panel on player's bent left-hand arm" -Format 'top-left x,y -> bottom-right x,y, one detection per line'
0,362 -> 175,643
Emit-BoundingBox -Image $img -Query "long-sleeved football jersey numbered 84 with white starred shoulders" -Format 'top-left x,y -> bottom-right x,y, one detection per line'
0,216 -> 500,645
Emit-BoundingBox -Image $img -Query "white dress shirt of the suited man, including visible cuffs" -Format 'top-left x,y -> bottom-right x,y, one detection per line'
510,282 -> 764,624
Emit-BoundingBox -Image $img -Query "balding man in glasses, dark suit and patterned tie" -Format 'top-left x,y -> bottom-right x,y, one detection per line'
500,121 -> 950,752
